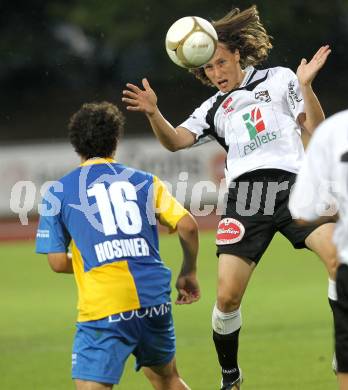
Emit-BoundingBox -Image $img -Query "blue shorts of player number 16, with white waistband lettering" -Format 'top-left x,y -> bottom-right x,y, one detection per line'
72,303 -> 175,384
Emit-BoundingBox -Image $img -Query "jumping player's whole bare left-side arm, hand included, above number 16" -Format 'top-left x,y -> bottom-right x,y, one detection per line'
122,79 -> 195,152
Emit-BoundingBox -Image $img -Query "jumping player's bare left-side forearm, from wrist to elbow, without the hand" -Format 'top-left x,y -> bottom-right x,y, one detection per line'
146,108 -> 192,152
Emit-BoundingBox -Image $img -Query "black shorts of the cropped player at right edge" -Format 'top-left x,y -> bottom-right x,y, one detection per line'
334,264 -> 348,373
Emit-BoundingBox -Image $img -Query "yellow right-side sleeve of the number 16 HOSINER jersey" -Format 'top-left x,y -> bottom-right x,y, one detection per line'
154,176 -> 188,232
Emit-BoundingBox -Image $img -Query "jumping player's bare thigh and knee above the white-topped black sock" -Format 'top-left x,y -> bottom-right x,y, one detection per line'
217,254 -> 256,311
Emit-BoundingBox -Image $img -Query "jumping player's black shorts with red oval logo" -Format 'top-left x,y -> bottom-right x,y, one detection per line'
216,169 -> 319,263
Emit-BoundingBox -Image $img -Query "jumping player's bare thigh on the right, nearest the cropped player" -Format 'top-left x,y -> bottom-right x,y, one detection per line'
305,223 -> 338,279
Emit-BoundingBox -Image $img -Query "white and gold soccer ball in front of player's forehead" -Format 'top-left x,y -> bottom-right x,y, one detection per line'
166,16 -> 218,69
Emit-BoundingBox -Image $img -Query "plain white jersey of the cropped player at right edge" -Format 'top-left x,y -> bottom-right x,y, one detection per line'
289,110 -> 348,264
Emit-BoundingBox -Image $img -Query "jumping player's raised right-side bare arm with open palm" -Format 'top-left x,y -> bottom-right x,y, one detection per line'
296,45 -> 331,134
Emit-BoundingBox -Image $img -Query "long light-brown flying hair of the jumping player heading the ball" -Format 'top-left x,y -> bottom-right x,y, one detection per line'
190,5 -> 272,86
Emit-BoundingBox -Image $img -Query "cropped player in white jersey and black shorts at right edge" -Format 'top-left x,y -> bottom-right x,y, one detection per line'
289,110 -> 348,390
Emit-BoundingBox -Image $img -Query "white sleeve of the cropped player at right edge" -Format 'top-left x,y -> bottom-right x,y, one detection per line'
289,122 -> 333,221
